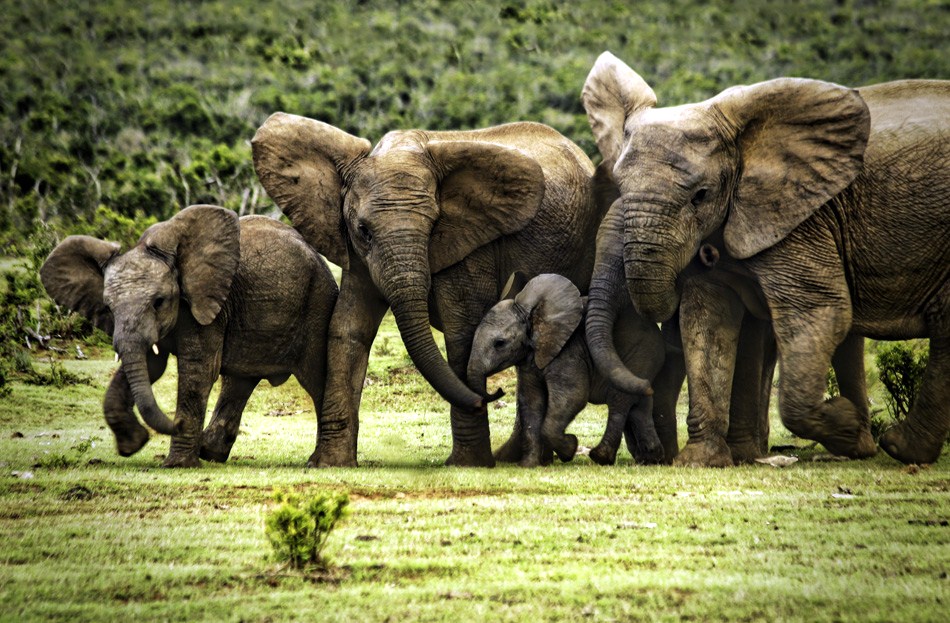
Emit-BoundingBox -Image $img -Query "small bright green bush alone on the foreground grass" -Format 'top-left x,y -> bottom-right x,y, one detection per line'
264,491 -> 350,569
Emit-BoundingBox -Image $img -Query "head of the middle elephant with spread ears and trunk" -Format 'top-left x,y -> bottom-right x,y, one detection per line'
252,113 -> 544,410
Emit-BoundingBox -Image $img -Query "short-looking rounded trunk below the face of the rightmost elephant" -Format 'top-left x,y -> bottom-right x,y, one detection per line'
621,196 -> 698,322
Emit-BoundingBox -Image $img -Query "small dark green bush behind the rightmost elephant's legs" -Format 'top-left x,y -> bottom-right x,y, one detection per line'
875,341 -> 930,422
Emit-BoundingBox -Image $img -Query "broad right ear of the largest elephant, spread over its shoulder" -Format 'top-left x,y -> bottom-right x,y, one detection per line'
709,78 -> 871,259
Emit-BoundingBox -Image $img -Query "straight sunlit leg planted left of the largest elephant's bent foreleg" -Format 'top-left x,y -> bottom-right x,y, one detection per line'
674,278 -> 745,467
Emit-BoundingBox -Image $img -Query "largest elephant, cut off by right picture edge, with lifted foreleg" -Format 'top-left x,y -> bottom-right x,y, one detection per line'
585,53 -> 950,463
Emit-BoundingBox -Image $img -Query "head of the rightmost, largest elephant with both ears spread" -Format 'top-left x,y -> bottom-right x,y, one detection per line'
582,52 -> 870,320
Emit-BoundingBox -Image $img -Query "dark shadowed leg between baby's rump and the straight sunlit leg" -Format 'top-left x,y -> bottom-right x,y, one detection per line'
652,315 -> 686,464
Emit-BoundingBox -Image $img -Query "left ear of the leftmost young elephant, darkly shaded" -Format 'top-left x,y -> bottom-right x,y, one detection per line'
40,236 -> 119,335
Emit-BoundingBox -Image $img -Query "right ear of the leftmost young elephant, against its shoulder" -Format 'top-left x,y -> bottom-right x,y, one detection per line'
146,205 -> 241,325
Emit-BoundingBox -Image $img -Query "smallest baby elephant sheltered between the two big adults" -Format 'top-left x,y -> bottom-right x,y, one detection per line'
468,274 -> 665,466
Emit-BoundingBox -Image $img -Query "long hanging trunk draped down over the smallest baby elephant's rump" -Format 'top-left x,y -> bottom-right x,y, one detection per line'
585,202 -> 653,395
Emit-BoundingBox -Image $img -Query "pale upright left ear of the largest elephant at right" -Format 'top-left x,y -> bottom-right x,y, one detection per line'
581,52 -> 656,170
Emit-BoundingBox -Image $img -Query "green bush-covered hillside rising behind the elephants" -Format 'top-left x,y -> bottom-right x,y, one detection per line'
0,0 -> 950,249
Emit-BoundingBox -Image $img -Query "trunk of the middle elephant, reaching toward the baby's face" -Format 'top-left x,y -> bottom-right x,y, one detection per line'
378,235 -> 485,411
